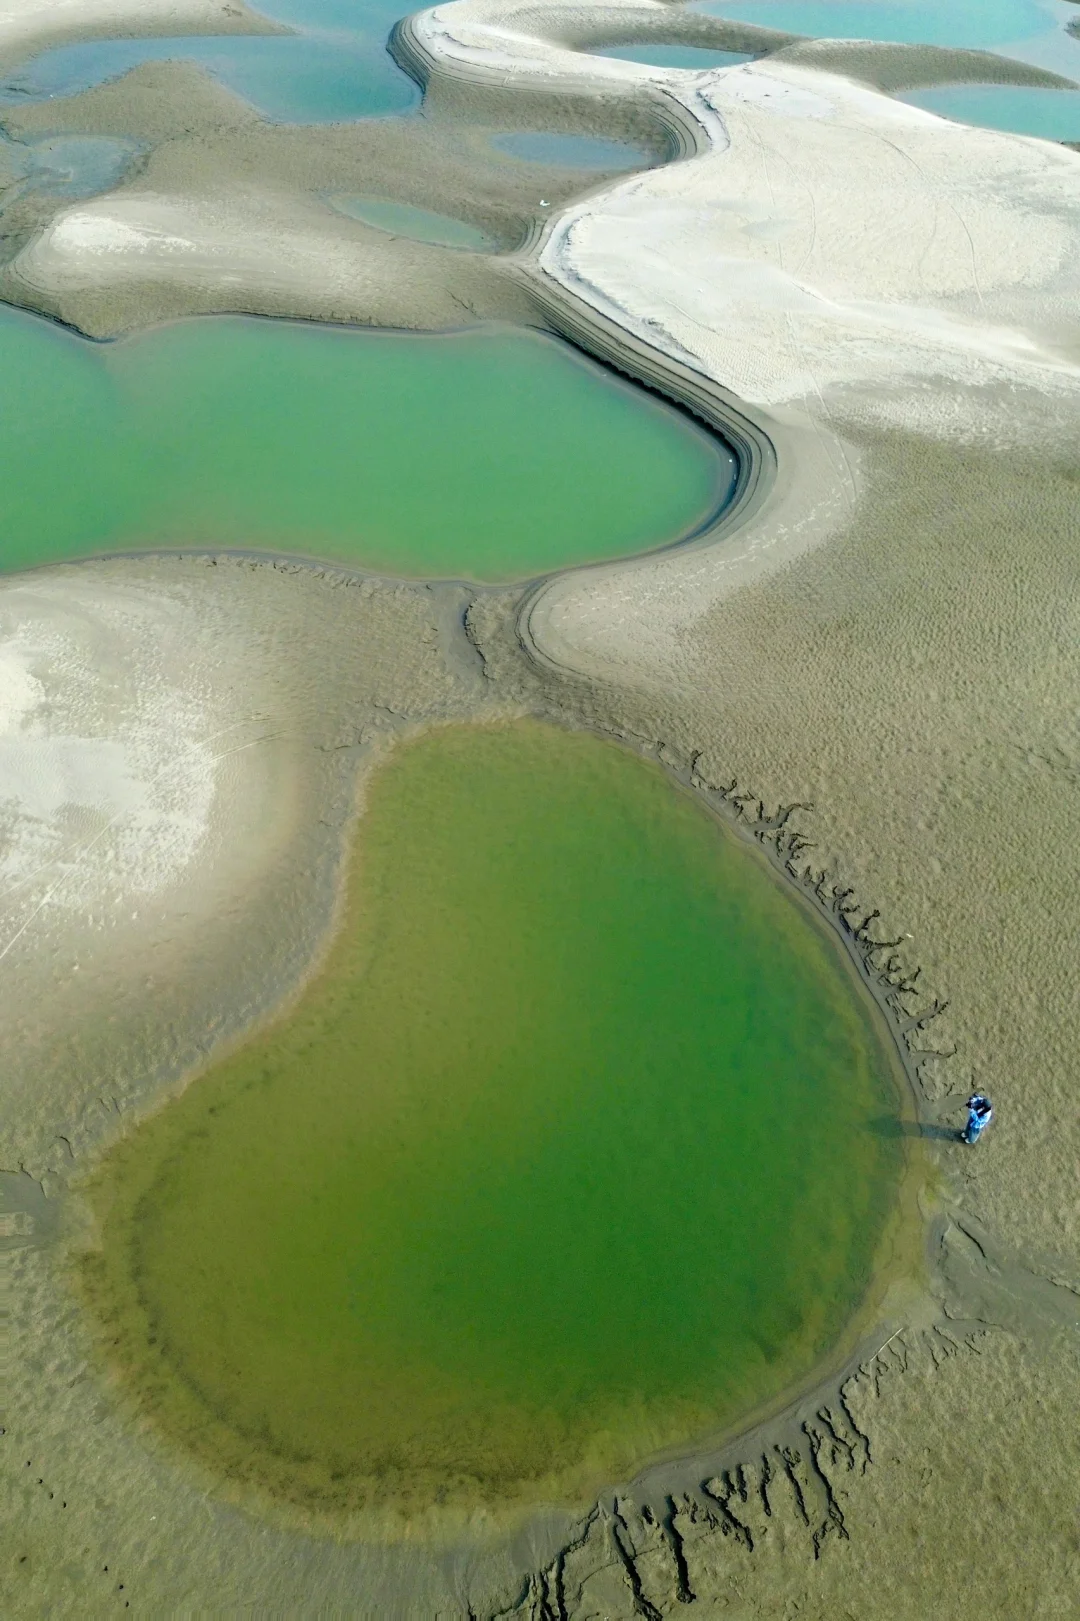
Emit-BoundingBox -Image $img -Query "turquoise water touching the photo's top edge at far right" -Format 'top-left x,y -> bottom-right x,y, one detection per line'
694,0 -> 1080,78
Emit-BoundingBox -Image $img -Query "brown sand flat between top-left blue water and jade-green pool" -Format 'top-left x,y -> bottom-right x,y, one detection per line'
0,62 -> 564,337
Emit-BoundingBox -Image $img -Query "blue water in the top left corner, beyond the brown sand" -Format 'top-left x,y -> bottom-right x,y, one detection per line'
0,0 -> 420,123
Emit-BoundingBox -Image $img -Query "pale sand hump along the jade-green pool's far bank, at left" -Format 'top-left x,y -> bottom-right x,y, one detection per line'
0,164 -> 548,337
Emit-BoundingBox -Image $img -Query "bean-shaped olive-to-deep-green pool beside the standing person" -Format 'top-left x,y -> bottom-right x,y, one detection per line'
81,723 -> 902,1514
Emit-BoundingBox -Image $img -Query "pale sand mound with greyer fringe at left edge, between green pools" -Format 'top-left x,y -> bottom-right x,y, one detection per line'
0,566 -> 302,1164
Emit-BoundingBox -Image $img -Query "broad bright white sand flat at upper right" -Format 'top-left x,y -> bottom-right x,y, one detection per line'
540,63 -> 1080,408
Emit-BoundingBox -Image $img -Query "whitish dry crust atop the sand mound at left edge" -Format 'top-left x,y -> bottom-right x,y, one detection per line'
0,574 -> 221,956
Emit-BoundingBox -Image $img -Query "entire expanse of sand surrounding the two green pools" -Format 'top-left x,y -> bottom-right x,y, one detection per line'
0,0 -> 1080,1621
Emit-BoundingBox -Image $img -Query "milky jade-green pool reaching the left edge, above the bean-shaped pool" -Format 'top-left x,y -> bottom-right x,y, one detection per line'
0,310 -> 736,580
